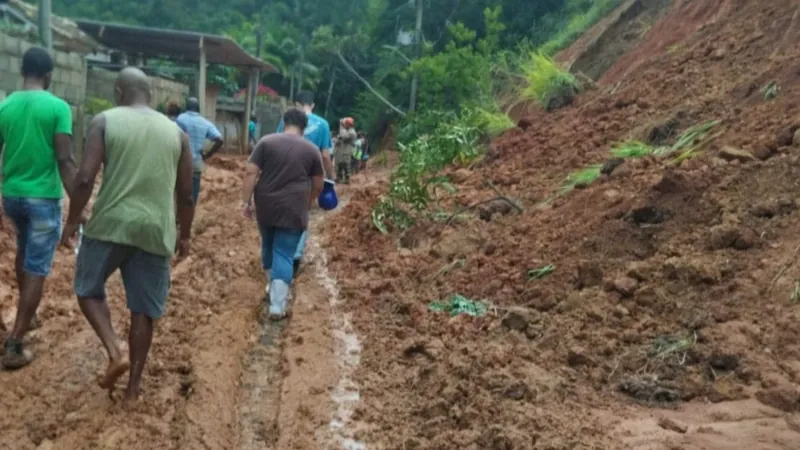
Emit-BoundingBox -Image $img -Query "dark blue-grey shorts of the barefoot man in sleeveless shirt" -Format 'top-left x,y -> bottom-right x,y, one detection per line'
75,236 -> 170,319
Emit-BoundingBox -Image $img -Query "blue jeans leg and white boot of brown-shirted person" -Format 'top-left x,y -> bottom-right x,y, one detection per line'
269,228 -> 303,320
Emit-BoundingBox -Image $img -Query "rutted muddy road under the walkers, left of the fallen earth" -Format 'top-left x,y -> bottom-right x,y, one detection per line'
0,158 -> 368,450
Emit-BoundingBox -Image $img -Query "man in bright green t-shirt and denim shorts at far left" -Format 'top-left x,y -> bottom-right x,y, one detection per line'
0,47 -> 76,370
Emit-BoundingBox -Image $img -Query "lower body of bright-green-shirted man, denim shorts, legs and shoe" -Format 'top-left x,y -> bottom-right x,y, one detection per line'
2,199 -> 61,370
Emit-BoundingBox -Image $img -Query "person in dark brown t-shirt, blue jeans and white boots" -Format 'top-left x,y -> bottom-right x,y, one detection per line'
242,108 -> 324,320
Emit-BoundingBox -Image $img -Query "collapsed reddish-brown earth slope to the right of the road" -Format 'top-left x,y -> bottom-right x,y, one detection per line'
326,0 -> 800,449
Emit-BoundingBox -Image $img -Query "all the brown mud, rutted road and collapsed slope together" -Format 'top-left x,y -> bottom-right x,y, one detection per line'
0,0 -> 800,450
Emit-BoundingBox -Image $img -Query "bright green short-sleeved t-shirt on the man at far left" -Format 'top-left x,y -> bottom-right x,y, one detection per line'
0,91 -> 72,198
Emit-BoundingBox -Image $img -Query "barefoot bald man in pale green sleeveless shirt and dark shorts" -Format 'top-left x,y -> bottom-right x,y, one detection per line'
63,68 -> 194,401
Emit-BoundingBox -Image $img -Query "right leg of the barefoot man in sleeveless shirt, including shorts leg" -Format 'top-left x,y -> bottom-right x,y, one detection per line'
120,249 -> 170,401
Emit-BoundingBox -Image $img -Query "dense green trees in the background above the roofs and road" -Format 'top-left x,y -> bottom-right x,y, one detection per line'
53,0 -> 619,126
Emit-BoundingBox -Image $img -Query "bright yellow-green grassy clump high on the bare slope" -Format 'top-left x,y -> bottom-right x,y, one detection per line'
522,52 -> 581,111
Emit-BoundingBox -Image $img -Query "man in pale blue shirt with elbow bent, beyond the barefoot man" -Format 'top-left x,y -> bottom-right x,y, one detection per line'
175,97 -> 223,205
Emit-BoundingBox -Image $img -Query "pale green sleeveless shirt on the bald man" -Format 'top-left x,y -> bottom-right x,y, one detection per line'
85,107 -> 181,257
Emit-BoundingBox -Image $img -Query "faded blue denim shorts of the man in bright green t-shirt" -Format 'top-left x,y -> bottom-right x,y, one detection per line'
3,197 -> 61,277
